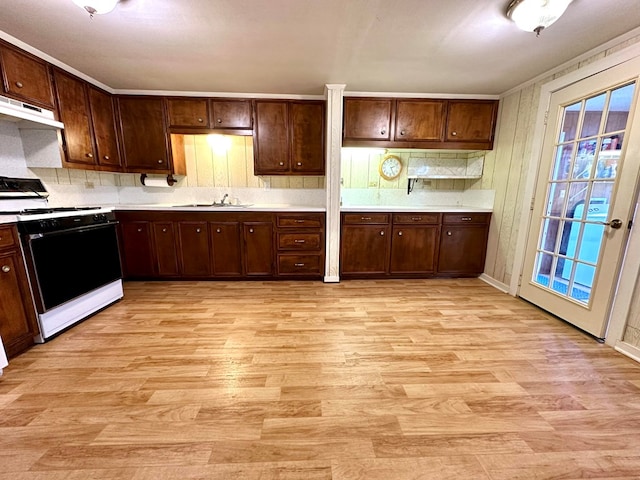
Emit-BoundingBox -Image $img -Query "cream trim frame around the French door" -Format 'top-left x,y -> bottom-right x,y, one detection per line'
509,42 -> 640,346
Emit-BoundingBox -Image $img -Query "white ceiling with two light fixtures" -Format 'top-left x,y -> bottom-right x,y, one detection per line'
0,0 -> 640,95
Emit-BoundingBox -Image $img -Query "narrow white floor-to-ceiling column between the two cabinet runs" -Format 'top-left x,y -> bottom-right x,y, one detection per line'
324,84 -> 346,282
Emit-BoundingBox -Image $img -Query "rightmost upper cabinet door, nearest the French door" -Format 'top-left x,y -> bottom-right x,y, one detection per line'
446,100 -> 498,142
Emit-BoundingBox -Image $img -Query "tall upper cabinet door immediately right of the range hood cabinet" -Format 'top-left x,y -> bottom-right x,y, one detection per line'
53,69 -> 96,165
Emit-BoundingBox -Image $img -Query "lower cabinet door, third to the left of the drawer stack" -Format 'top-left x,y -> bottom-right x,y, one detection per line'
178,222 -> 211,277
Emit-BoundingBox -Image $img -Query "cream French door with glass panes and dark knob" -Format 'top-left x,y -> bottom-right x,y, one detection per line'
519,58 -> 640,338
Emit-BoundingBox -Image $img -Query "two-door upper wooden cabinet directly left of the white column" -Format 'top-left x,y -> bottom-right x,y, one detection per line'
254,100 -> 325,175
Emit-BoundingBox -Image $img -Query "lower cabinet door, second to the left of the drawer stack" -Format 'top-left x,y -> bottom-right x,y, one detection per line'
209,222 -> 242,277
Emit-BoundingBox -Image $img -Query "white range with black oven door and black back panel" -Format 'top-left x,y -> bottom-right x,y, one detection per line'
0,177 -> 123,343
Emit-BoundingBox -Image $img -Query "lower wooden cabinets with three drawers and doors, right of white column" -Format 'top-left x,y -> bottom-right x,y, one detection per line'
340,212 -> 491,279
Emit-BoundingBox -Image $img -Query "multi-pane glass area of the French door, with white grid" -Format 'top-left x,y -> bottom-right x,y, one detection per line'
532,80 -> 635,307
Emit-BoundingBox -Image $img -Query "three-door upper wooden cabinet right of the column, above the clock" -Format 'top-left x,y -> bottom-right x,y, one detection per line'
343,97 -> 498,150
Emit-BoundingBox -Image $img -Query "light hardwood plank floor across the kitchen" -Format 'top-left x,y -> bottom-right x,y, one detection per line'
0,279 -> 640,480
